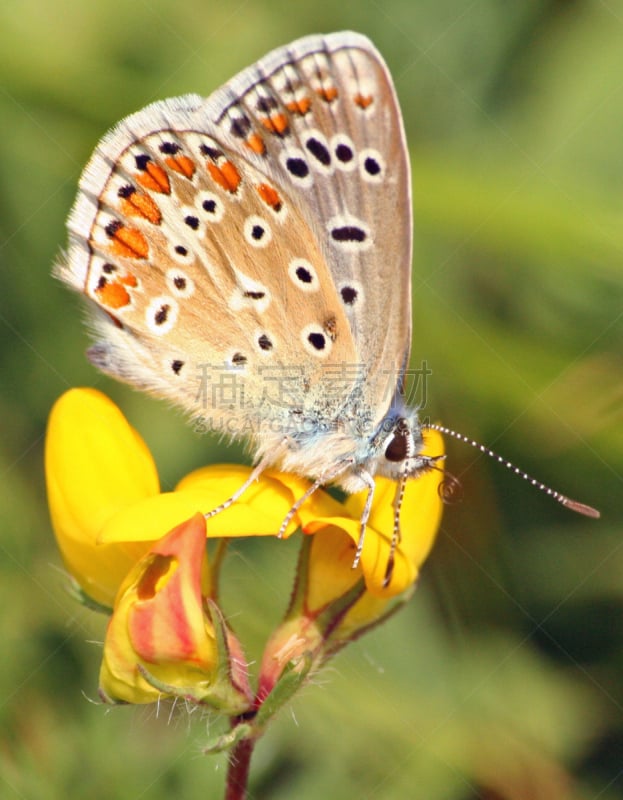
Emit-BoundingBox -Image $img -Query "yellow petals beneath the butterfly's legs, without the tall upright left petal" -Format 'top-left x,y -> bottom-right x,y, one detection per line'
100,446 -> 443,597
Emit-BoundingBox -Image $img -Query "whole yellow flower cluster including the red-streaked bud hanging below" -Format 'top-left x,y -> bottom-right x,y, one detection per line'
46,389 -> 443,712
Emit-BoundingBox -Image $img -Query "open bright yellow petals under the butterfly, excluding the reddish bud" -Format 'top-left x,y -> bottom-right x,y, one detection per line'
46,389 -> 443,606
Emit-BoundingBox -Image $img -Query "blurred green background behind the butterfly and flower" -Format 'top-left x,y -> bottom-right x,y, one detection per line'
0,0 -> 623,800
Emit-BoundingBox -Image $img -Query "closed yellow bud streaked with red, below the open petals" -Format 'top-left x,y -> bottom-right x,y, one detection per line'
100,514 -> 253,714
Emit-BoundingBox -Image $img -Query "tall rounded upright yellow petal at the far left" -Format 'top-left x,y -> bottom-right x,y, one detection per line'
45,389 -> 159,605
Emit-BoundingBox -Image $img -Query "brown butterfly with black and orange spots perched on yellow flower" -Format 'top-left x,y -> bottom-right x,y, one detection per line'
57,32 -> 600,573
